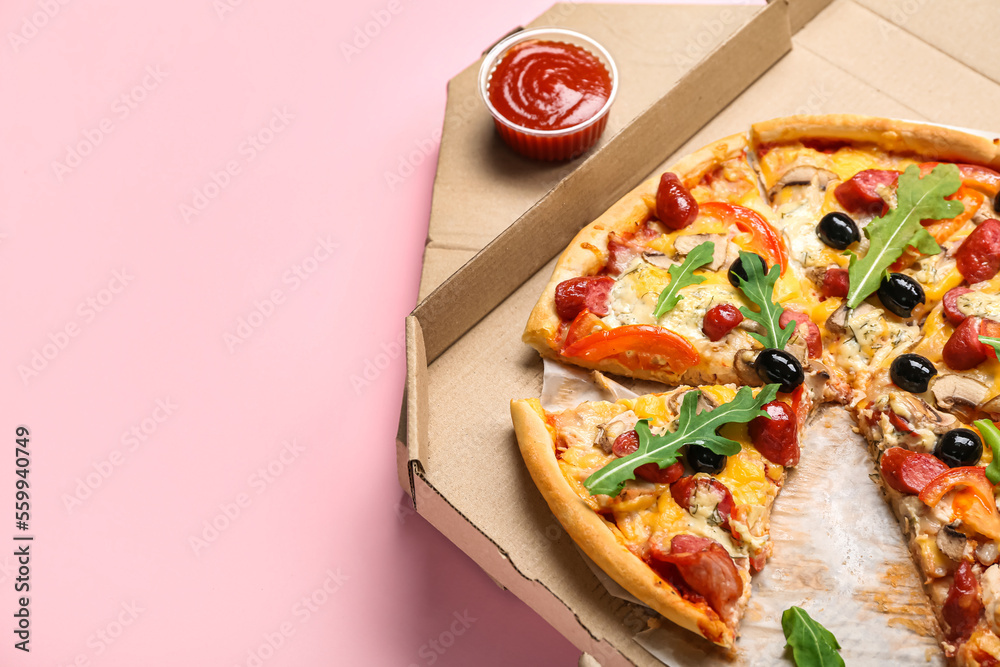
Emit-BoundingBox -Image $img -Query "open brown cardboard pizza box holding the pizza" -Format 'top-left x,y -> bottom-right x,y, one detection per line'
397,0 -> 1000,667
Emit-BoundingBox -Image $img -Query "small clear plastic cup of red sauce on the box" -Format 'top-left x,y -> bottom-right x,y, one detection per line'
479,28 -> 618,160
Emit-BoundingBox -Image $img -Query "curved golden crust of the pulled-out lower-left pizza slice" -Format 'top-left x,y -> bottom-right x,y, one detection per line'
510,399 -> 750,648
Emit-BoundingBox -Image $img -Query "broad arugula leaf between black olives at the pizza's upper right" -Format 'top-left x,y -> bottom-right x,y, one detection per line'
847,164 -> 964,308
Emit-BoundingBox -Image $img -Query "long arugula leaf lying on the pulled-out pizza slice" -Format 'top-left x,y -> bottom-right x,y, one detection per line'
583,384 -> 778,496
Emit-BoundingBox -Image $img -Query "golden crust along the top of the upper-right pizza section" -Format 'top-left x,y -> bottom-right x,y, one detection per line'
750,114 -> 1000,169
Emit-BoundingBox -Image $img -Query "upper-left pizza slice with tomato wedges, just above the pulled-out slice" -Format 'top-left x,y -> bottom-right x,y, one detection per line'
523,130 -> 849,400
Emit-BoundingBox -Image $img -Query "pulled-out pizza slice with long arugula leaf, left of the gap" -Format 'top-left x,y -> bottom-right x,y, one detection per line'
511,385 -> 814,648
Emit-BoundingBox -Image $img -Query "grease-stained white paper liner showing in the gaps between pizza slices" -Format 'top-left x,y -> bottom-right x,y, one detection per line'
543,361 -> 946,667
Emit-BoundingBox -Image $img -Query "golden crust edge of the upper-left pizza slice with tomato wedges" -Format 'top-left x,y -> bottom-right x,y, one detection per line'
521,134 -> 748,384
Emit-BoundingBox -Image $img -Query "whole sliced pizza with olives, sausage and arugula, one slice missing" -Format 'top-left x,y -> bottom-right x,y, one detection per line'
511,115 -> 1000,665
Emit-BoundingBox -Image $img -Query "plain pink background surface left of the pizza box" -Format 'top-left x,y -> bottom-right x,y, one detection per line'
0,0 -> 748,667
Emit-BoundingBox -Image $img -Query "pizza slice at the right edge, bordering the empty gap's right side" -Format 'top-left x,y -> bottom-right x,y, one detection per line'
857,277 -> 1000,666
